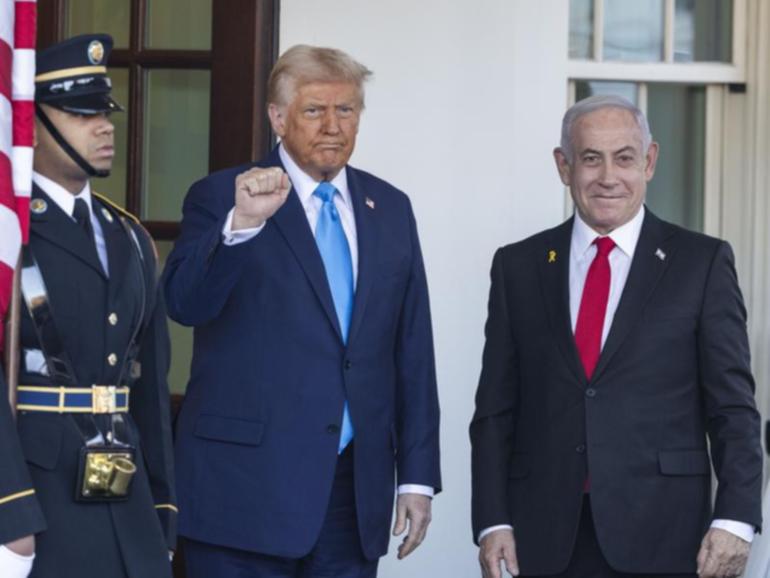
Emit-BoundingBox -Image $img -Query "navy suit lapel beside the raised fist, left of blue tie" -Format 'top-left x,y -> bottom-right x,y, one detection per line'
266,149 -> 342,341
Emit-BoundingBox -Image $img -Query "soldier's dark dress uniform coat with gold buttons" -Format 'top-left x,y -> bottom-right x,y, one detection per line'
6,186 -> 176,578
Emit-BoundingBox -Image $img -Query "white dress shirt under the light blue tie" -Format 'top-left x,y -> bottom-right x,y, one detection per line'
222,145 -> 434,497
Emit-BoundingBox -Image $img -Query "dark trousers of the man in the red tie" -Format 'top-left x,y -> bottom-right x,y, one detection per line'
520,493 -> 698,578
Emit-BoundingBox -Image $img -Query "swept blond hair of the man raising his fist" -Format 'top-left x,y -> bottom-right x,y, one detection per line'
267,44 -> 372,108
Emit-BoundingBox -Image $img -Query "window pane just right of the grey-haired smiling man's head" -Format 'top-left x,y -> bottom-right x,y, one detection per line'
647,84 -> 706,231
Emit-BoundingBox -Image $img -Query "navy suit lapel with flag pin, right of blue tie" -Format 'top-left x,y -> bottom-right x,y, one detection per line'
346,167 -> 379,343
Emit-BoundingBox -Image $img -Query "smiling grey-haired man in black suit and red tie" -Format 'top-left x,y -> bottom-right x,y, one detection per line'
470,96 -> 762,578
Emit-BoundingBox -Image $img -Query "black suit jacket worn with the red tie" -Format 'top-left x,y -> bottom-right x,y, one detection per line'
470,211 -> 762,574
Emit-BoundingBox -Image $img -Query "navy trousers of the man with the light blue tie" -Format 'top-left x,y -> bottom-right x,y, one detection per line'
184,443 -> 379,578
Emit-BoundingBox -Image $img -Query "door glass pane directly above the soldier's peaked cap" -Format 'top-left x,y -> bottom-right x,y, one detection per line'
65,0 -> 131,48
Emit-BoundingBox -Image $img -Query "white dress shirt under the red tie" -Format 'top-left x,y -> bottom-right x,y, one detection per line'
479,206 -> 754,542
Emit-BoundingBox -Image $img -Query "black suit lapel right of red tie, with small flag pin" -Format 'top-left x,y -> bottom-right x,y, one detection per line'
592,210 -> 675,381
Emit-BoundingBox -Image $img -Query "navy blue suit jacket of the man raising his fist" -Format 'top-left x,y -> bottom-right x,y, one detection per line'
164,151 -> 441,558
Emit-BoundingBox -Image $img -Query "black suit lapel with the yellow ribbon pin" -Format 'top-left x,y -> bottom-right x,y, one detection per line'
536,219 -> 586,385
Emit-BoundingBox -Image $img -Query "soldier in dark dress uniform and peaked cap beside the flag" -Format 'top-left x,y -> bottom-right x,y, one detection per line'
0,35 -> 176,578
